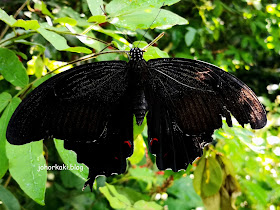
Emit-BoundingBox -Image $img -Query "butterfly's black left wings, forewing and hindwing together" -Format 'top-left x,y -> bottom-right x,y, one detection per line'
7,61 -> 133,187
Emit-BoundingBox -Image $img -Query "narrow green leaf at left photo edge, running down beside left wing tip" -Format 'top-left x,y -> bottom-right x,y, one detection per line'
0,98 -> 21,178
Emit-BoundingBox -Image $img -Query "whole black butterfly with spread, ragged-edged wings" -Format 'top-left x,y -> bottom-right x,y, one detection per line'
7,48 -> 267,190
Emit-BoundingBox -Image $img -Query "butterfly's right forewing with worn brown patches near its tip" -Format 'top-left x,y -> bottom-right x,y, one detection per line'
148,58 -> 266,131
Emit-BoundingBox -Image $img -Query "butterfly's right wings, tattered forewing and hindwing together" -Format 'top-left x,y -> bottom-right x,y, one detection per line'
146,58 -> 266,171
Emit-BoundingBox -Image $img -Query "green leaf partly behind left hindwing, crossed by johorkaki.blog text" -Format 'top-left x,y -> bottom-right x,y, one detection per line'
54,139 -> 88,181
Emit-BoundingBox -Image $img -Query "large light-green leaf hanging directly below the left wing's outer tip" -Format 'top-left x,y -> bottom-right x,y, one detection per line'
6,141 -> 47,205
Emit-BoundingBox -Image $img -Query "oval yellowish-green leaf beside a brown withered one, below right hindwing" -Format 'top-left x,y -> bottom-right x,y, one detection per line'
193,156 -> 223,197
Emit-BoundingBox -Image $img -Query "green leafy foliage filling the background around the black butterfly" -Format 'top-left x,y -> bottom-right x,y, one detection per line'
0,0 -> 280,210
